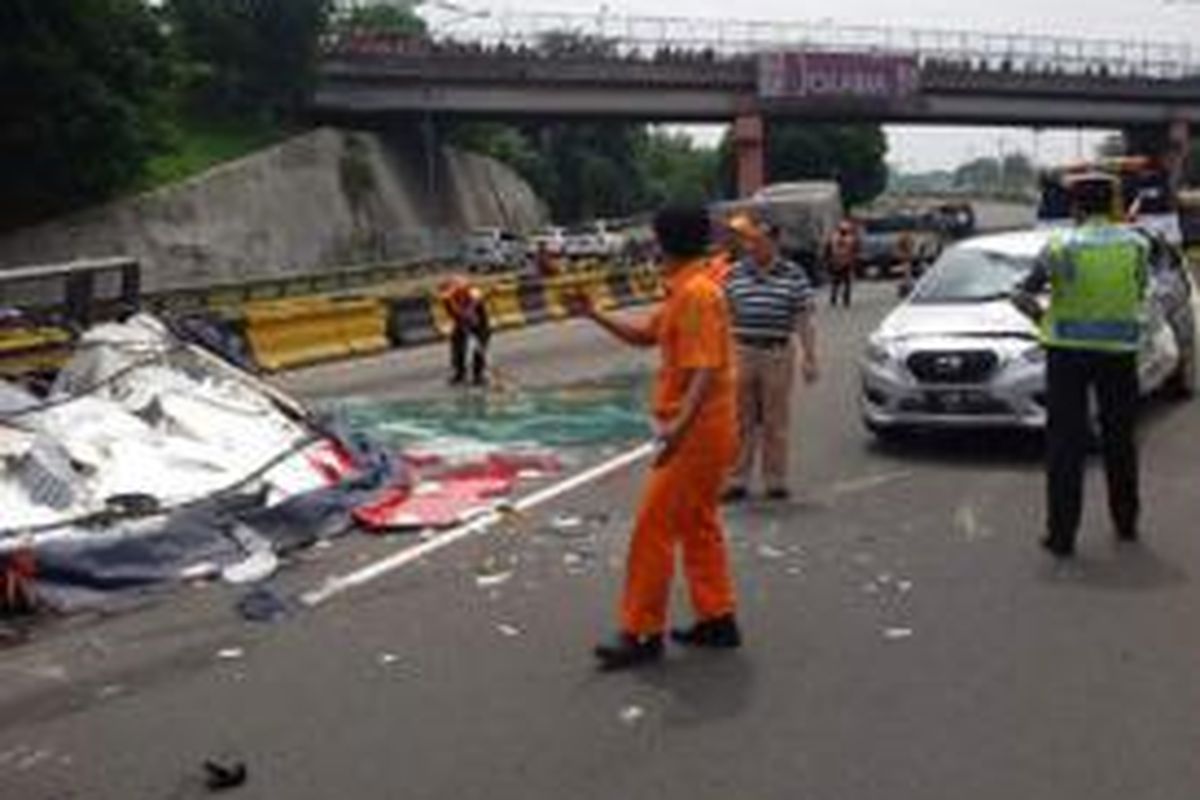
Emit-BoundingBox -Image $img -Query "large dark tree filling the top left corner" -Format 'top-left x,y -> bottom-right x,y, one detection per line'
0,0 -> 175,227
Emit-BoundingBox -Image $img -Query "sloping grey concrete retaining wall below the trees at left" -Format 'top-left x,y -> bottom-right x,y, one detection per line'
0,128 -> 545,291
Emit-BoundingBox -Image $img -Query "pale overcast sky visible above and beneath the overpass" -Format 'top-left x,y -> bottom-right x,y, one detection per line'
422,0 -> 1200,172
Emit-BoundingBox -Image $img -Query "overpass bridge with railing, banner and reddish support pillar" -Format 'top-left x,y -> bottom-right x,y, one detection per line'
313,12 -> 1200,192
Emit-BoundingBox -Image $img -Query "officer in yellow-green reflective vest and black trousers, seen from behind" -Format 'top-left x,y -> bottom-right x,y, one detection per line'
1014,174 -> 1147,559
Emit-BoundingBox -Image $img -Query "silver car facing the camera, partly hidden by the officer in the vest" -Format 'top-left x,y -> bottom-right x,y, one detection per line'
860,229 -> 1195,435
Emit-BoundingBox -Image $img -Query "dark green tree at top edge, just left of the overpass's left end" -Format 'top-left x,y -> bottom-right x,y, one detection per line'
167,0 -> 330,119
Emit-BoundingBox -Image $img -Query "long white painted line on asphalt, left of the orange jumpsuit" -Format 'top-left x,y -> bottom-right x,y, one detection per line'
300,441 -> 655,607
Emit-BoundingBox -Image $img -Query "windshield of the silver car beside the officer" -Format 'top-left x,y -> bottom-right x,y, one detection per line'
912,247 -> 1033,302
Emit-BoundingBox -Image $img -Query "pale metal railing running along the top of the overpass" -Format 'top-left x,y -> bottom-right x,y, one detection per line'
324,0 -> 1200,79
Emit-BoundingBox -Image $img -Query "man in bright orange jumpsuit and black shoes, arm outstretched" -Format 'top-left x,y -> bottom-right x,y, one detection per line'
571,207 -> 742,670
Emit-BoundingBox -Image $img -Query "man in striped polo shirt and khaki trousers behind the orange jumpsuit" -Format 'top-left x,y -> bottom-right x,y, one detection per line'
725,212 -> 818,503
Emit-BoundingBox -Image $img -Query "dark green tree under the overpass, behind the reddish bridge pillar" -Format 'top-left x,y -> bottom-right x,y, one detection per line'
720,122 -> 888,205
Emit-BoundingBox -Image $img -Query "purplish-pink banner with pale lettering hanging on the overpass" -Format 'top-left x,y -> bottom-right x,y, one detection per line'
758,52 -> 919,100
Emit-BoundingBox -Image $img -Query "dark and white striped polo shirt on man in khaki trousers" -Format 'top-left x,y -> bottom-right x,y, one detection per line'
725,258 -> 812,342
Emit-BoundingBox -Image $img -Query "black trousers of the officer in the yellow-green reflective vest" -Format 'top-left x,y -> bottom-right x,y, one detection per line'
1046,348 -> 1139,545
